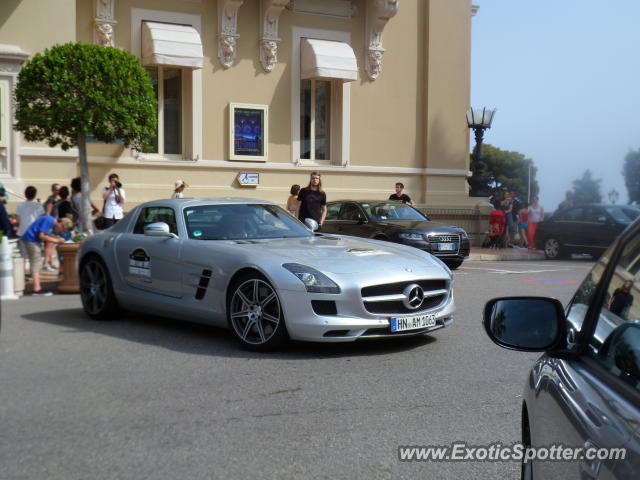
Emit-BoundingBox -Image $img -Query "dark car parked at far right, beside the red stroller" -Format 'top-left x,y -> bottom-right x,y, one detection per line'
535,204 -> 640,259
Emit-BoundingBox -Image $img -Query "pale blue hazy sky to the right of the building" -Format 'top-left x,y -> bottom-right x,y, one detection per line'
470,0 -> 640,212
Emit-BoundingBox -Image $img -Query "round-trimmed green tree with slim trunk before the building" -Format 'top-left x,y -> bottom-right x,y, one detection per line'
14,43 -> 157,231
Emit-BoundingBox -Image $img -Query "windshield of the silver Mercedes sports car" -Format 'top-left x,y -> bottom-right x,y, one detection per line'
184,204 -> 313,240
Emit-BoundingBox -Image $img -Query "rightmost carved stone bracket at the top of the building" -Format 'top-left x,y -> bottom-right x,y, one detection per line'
365,0 -> 400,81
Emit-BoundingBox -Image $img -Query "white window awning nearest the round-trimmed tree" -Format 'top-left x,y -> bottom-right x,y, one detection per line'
142,22 -> 203,68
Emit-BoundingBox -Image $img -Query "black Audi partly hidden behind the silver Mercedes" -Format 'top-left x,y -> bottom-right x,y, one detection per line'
322,200 -> 469,270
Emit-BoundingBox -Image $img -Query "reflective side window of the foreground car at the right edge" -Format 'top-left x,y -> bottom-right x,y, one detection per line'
589,232 -> 640,388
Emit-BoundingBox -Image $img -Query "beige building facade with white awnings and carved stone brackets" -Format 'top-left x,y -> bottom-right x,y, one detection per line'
0,0 -> 476,207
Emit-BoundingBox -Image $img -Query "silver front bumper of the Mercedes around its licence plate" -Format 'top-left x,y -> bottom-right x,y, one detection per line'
279,289 -> 455,342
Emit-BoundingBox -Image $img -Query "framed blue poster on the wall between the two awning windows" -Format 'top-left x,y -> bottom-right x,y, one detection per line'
229,103 -> 269,162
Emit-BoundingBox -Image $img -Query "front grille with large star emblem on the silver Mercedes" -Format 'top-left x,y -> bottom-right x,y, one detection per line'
360,280 -> 449,315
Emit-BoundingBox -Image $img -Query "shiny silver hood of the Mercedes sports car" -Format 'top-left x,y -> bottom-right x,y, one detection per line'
230,235 -> 446,276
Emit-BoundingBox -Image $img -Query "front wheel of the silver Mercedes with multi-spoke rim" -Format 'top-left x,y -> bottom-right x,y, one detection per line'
227,272 -> 288,352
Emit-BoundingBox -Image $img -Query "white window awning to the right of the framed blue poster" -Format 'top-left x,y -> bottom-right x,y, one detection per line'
300,38 -> 358,82
